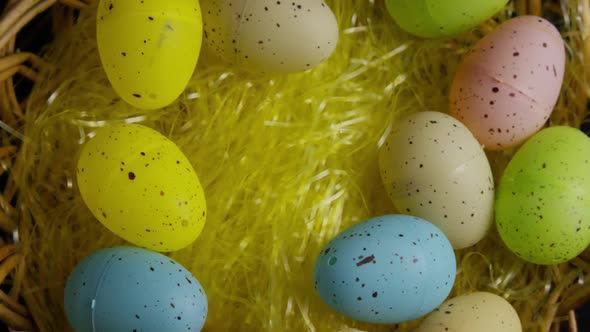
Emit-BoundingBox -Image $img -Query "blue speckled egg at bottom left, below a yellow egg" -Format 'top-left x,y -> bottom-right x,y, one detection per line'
64,247 -> 207,332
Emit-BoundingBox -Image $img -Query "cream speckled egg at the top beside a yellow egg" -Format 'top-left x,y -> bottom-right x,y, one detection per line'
201,0 -> 338,73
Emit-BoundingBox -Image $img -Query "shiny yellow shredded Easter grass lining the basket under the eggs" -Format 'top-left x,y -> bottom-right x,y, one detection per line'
14,0 -> 590,331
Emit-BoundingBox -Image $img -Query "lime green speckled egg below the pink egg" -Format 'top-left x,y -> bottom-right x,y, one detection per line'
496,127 -> 590,264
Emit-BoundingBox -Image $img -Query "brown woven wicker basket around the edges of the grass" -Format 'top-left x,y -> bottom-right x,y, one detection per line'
0,0 -> 590,331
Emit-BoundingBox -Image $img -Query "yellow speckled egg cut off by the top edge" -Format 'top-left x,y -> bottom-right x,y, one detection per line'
96,0 -> 203,109
